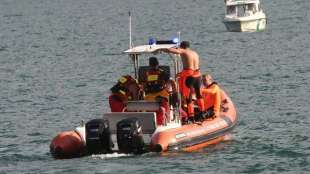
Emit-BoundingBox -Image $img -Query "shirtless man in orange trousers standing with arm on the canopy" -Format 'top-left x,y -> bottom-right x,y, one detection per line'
158,41 -> 205,119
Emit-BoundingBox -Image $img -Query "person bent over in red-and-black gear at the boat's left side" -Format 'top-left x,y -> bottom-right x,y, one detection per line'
109,75 -> 139,112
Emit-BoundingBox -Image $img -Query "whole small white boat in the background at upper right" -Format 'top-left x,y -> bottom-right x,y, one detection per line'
223,0 -> 266,32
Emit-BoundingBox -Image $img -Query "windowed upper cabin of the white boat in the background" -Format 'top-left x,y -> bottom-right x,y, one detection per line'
226,0 -> 261,17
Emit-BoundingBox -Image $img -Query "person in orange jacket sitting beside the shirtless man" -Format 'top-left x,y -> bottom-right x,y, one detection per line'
201,74 -> 221,118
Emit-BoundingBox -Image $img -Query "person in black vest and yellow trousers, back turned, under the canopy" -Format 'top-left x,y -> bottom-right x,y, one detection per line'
142,57 -> 169,125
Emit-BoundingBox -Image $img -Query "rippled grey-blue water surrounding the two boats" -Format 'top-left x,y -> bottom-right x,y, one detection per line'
0,0 -> 310,174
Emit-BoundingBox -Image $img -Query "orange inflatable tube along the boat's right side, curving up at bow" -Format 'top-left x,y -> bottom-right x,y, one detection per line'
150,91 -> 237,152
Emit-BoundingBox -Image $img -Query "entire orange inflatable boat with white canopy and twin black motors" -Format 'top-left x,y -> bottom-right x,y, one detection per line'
50,41 -> 237,158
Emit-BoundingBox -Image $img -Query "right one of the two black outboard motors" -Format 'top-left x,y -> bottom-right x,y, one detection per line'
116,118 -> 145,154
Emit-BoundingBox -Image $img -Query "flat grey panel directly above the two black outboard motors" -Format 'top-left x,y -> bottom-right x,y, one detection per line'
103,112 -> 157,134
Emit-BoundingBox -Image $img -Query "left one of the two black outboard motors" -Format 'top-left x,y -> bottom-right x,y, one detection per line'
86,119 -> 113,154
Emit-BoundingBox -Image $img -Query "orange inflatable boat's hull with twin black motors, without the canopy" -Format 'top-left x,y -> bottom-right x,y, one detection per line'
50,91 -> 237,158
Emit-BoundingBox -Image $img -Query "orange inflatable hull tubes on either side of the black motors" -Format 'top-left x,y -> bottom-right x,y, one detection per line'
50,90 -> 237,158
